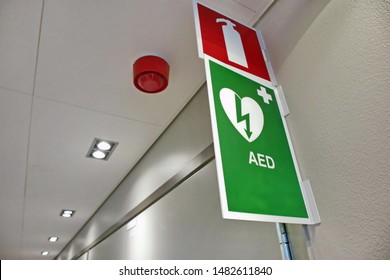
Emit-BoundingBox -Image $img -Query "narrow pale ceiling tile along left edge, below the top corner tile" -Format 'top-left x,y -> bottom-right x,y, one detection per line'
0,88 -> 31,259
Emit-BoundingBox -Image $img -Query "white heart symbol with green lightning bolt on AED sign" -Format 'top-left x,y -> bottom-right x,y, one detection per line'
219,88 -> 264,142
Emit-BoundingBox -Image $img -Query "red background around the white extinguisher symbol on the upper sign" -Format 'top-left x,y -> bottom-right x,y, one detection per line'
197,3 -> 270,81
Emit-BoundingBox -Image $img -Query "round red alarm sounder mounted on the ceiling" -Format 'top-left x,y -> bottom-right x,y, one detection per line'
133,55 -> 169,93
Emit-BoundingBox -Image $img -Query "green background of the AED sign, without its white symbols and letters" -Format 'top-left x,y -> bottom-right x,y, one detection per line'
210,61 -> 308,218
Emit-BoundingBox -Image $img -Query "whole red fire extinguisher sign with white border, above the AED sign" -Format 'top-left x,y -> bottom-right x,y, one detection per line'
195,3 -> 270,81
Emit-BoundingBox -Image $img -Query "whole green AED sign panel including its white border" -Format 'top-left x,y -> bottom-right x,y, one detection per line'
205,57 -> 311,223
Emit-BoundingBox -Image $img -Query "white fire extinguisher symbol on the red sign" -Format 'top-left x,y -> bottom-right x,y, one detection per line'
217,18 -> 248,68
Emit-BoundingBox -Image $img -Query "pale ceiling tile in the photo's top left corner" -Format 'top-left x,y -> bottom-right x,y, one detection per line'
0,0 -> 42,94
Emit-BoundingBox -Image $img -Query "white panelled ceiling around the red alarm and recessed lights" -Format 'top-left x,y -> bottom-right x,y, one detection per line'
0,0 -> 273,259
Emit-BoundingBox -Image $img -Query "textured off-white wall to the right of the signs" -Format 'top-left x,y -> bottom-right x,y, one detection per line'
266,0 -> 390,259
